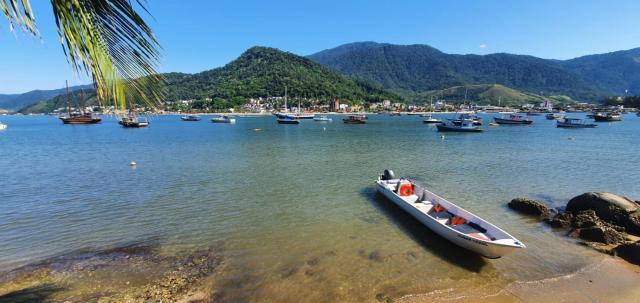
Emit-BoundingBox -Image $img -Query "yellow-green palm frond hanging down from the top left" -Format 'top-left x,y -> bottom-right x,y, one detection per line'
0,0 -> 165,110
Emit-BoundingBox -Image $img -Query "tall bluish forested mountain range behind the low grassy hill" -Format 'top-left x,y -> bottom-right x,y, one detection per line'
309,42 -> 640,101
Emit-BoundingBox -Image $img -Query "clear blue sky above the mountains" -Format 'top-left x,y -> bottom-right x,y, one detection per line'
0,0 -> 640,93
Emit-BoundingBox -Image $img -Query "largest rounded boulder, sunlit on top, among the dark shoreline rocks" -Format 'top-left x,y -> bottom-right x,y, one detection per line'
567,192 -> 639,226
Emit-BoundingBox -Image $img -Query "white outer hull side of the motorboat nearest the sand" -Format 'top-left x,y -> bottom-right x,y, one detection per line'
376,181 -> 524,259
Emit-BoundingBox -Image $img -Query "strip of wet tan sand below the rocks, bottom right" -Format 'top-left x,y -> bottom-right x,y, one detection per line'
397,257 -> 640,303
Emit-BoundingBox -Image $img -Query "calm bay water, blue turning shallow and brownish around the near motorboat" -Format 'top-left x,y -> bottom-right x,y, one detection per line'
0,114 -> 640,302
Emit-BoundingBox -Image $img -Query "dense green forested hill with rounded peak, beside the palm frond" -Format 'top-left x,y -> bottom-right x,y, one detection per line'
165,47 -> 398,101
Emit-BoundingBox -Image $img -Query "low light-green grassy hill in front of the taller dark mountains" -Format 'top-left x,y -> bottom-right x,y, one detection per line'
414,84 -> 574,106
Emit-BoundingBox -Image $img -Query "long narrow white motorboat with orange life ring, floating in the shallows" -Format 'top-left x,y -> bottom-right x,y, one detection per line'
376,170 -> 526,259
